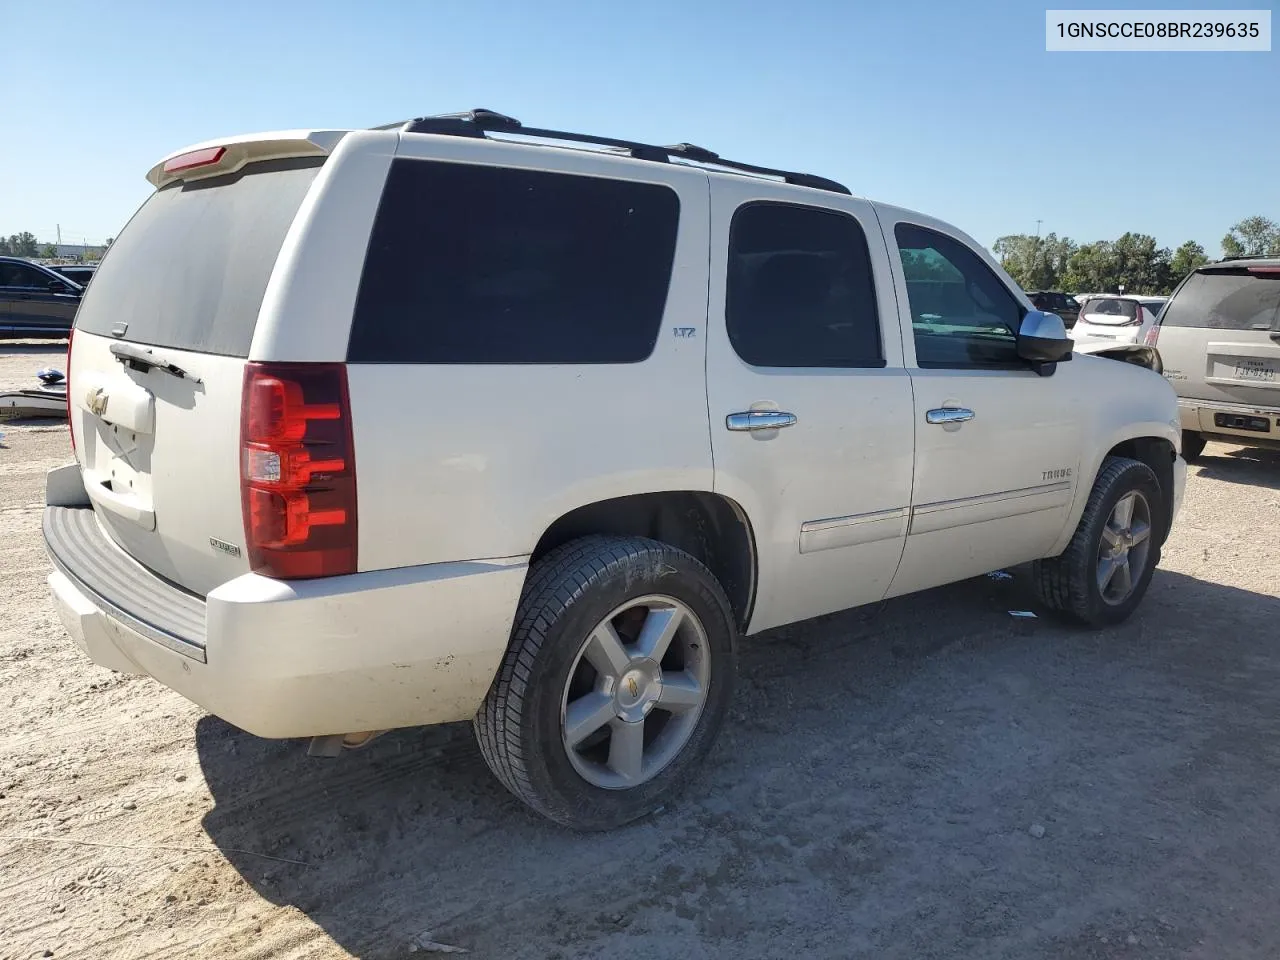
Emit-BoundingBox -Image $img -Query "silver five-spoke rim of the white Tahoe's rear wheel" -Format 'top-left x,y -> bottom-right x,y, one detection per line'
561,595 -> 710,790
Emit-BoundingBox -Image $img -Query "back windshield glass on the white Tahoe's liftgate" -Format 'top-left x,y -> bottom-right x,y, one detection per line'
76,157 -> 323,357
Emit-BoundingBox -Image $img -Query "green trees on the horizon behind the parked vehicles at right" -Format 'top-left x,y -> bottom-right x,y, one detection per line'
992,216 -> 1280,294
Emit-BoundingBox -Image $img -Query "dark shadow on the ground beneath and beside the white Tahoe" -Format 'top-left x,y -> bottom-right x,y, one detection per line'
196,571 -> 1280,960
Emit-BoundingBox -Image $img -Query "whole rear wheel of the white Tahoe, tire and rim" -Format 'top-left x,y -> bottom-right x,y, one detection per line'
475,536 -> 736,829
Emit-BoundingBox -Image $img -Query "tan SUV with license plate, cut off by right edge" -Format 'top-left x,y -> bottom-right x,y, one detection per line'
1158,257 -> 1280,461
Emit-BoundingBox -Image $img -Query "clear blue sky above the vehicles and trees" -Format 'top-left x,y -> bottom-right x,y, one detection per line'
0,0 -> 1280,255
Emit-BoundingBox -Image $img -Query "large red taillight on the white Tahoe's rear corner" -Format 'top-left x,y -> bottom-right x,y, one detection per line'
241,364 -> 356,580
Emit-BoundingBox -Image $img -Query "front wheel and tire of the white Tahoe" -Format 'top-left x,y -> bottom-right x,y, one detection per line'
1033,457 -> 1166,627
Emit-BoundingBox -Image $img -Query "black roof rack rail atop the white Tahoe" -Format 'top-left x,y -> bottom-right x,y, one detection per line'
374,108 -> 851,195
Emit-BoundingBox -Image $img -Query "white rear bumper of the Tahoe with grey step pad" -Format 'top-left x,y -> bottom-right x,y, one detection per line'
45,496 -> 527,737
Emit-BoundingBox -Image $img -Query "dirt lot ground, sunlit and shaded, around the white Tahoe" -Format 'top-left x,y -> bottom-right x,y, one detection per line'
0,346 -> 1280,960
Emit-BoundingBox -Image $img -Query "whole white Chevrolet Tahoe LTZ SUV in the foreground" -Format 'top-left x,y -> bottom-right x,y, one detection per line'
44,111 -> 1185,828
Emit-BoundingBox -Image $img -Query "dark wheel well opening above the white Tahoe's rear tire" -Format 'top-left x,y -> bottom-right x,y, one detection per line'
530,490 -> 758,630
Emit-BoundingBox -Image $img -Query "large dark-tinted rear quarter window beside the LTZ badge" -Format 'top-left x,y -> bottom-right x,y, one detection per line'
347,159 -> 680,364
